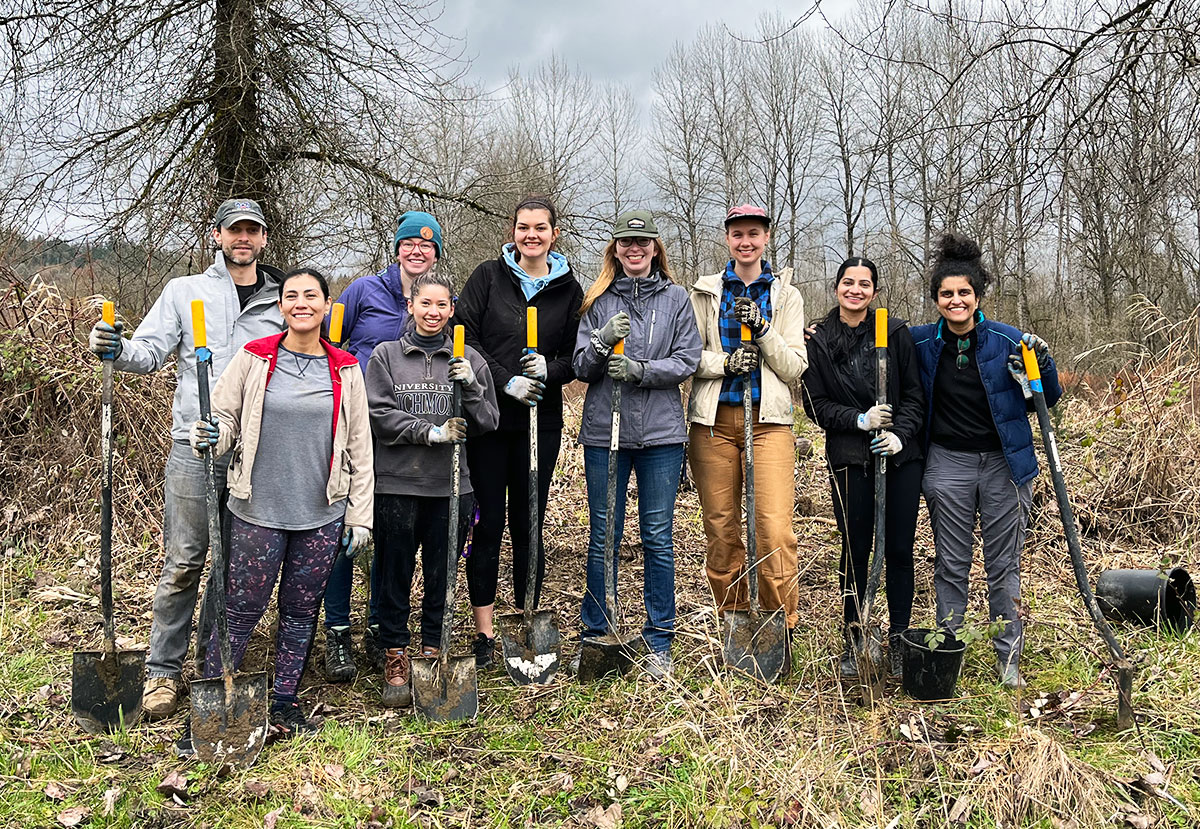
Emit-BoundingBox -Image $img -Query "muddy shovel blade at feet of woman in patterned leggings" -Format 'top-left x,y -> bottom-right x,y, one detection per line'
192,673 -> 268,767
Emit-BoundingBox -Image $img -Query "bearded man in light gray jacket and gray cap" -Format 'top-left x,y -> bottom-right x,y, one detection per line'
88,199 -> 286,717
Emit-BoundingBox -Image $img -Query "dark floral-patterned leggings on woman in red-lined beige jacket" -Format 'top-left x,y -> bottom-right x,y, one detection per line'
204,516 -> 342,701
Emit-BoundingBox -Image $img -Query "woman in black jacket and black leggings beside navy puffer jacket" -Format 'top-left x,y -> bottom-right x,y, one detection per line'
800,258 -> 925,677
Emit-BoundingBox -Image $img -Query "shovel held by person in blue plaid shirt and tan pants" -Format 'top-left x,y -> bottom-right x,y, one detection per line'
724,325 -> 787,683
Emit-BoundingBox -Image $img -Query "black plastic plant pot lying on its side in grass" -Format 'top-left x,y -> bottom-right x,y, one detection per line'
1096,567 -> 1196,633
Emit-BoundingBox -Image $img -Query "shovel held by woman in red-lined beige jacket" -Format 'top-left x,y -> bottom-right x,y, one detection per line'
192,300 -> 266,765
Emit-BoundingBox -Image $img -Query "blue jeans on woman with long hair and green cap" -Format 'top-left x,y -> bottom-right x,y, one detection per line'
582,444 -> 683,653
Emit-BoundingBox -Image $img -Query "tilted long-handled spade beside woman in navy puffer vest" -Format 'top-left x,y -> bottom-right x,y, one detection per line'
1021,343 -> 1133,731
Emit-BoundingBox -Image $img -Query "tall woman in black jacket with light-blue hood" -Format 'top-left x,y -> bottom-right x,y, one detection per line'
455,198 -> 583,668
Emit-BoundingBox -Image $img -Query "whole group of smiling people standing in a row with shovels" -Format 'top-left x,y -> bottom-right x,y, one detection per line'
89,198 -> 1061,734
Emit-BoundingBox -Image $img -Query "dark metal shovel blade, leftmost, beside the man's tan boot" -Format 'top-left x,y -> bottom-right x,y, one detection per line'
71,650 -> 146,734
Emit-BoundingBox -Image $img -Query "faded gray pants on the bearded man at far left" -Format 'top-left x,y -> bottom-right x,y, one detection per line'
146,440 -> 229,679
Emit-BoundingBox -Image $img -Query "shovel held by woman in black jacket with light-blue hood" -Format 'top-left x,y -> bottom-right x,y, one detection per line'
496,307 -> 563,685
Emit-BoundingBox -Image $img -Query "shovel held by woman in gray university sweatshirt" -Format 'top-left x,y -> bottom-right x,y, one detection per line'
412,325 -> 479,721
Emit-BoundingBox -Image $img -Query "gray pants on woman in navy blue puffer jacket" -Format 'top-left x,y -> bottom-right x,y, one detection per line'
923,444 -> 1033,665
